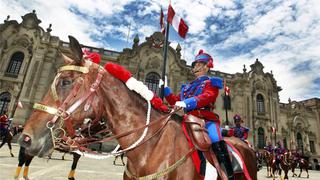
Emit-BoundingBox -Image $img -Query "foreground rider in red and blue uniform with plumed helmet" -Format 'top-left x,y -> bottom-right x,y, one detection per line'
164,50 -> 234,179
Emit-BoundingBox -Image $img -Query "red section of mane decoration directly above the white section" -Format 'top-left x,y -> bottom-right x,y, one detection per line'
104,63 -> 131,82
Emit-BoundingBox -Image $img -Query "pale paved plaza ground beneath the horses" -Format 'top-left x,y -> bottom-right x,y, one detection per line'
0,144 -> 320,180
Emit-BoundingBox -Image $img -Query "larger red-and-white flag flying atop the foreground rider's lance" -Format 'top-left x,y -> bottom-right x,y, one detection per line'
168,4 -> 189,38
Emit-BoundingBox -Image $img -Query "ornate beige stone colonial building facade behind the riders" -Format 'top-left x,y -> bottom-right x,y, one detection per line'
0,11 -> 320,163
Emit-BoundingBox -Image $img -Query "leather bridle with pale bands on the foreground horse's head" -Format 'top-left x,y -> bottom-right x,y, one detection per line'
33,61 -> 106,148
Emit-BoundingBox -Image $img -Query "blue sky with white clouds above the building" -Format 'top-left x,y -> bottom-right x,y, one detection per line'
0,0 -> 320,102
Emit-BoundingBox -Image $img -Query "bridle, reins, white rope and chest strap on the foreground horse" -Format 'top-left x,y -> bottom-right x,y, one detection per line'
33,62 -> 195,180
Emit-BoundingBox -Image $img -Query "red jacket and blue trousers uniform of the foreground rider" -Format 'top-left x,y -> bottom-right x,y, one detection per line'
164,76 -> 223,143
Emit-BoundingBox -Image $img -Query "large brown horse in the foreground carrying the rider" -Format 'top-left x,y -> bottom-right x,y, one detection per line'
19,37 -> 257,180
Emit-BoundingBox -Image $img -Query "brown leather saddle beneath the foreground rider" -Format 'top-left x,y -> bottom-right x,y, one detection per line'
184,115 -> 211,151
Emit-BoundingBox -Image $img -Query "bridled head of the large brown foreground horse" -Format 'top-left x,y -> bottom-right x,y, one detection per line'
18,36 -> 103,156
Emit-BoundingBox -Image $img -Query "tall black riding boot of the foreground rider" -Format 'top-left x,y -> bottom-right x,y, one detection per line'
212,140 -> 234,180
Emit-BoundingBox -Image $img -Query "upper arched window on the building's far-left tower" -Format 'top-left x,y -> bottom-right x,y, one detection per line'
6,51 -> 24,77
